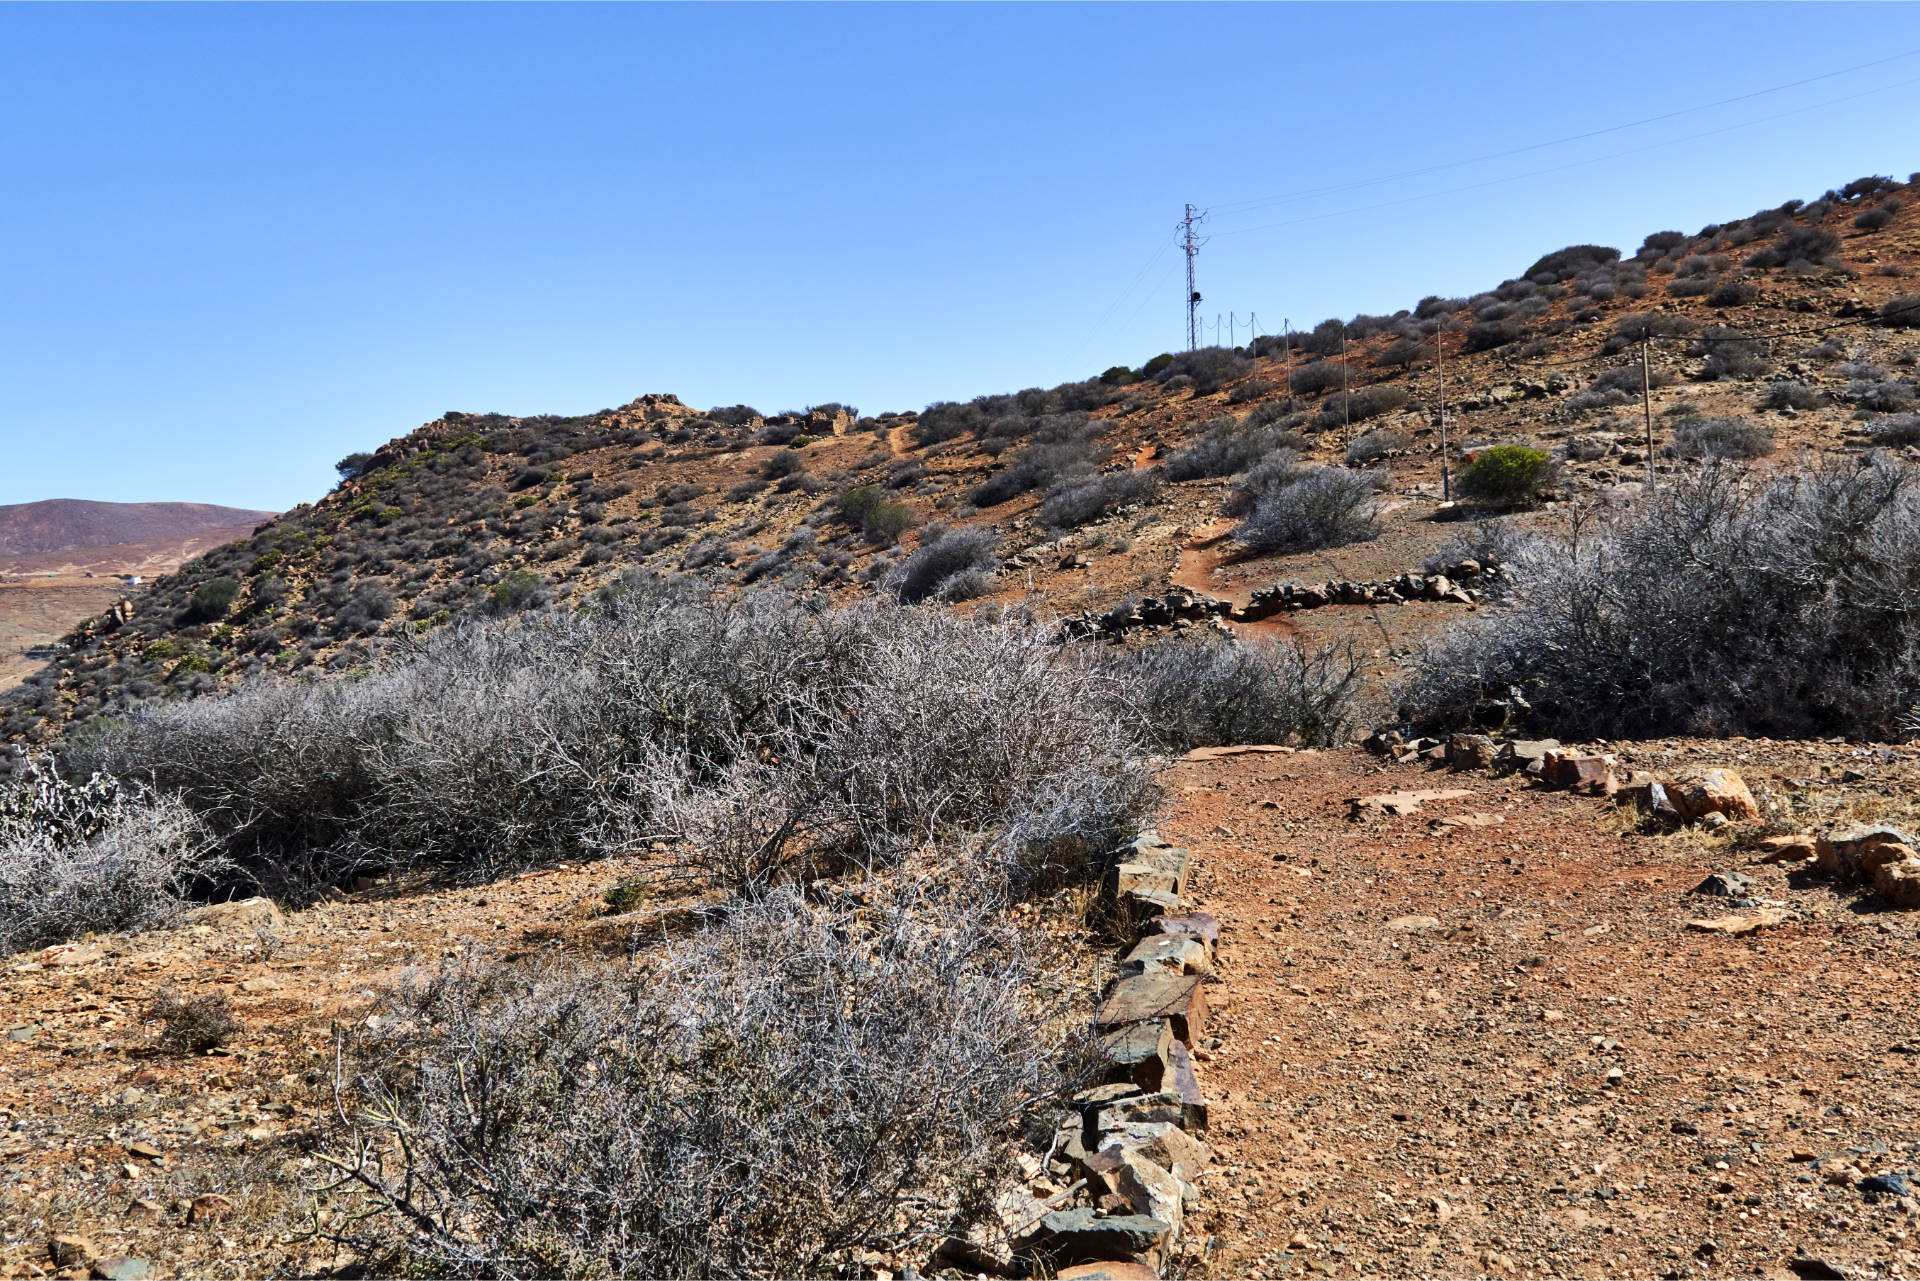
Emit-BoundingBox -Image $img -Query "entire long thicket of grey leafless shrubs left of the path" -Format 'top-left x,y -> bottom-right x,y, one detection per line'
75,591 -> 1150,895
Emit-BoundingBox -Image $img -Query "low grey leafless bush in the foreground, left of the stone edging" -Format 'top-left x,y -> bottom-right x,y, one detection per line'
318,893 -> 1062,1277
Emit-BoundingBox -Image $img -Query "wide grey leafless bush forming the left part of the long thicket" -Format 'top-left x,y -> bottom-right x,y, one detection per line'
73,592 -> 856,895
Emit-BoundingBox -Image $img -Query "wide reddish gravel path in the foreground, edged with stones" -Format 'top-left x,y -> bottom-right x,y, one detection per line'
1164,743 -> 1920,1277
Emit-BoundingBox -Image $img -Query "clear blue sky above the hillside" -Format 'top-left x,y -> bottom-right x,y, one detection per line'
0,4 -> 1920,509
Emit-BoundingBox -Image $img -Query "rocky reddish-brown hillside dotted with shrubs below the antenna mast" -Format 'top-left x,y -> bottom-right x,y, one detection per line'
0,179 -> 1920,741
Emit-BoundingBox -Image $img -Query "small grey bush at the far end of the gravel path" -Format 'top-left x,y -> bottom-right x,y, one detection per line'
1117,640 -> 1359,751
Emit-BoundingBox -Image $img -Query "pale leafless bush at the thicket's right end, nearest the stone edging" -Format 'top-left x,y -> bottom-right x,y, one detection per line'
645,611 -> 1156,893
